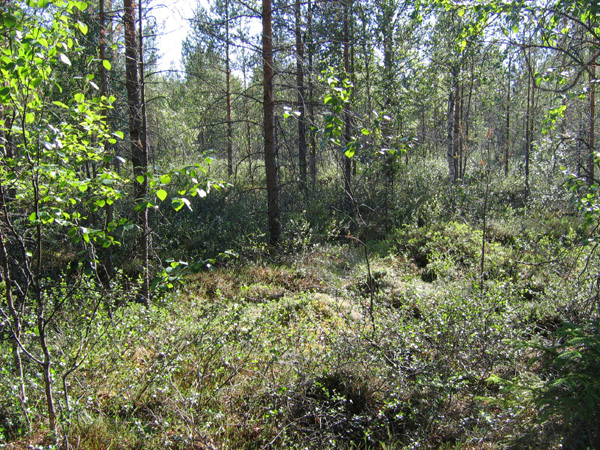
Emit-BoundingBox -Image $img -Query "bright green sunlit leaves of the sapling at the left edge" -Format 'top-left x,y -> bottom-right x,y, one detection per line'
0,0 -> 126,253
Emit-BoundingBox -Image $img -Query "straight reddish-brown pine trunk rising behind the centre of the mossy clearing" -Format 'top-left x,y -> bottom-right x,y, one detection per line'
262,0 -> 281,247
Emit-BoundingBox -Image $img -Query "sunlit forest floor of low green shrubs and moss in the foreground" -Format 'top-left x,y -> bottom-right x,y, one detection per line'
0,214 -> 600,449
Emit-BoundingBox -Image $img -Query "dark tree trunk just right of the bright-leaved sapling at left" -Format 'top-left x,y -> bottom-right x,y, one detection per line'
123,0 -> 149,303
